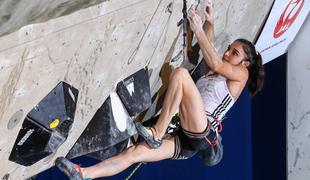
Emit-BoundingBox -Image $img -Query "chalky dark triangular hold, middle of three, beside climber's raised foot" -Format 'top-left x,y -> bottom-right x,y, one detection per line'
66,96 -> 136,159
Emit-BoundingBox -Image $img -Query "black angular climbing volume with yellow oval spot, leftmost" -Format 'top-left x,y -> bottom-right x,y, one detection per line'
9,82 -> 78,166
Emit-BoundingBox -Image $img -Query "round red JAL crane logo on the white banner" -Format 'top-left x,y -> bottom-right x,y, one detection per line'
273,0 -> 305,38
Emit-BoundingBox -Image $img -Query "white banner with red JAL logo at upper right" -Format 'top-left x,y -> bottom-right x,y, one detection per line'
256,0 -> 310,63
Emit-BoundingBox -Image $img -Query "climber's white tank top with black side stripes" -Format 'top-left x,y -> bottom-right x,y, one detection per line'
196,72 -> 235,121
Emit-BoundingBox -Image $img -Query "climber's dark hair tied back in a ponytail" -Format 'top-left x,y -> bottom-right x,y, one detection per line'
235,39 -> 265,96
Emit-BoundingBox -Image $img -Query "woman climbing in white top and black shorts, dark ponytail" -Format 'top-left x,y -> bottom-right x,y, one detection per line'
56,2 -> 264,179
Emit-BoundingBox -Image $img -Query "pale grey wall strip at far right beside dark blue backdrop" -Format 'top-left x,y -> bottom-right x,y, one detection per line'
287,15 -> 310,180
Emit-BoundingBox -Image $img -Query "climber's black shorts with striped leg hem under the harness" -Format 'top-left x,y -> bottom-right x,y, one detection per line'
172,125 -> 216,159
